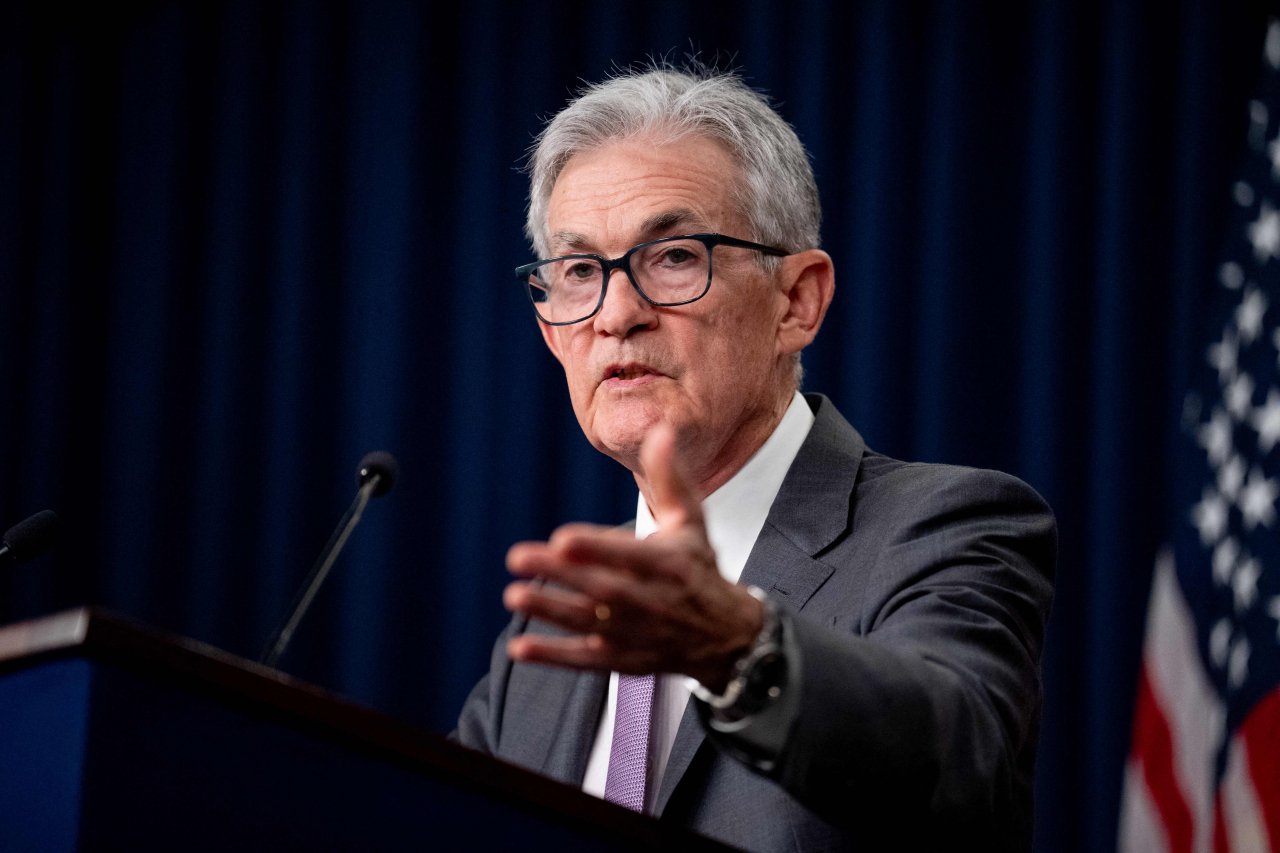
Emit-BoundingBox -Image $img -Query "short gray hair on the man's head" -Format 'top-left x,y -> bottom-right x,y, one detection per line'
525,63 -> 822,387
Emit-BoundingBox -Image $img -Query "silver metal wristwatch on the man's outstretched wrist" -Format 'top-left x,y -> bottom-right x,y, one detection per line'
689,587 -> 787,727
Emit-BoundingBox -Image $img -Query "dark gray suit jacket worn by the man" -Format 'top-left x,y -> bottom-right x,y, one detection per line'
454,394 -> 1056,850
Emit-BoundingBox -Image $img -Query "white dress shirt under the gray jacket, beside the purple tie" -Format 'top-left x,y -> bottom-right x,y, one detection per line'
582,392 -> 814,813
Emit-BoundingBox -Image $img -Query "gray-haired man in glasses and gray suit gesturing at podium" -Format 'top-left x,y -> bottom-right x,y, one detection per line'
456,68 -> 1056,850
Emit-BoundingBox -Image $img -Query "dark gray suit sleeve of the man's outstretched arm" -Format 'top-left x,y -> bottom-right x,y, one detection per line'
717,469 -> 1056,849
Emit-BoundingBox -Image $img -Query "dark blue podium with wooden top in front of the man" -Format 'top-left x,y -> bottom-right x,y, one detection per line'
0,607 -> 730,852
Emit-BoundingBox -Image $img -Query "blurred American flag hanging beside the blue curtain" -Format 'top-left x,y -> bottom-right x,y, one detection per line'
1119,20 -> 1280,853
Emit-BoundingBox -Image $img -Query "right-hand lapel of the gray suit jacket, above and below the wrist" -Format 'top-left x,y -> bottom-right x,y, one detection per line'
655,394 -> 867,816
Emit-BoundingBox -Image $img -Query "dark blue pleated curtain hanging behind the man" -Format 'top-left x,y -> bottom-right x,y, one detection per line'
0,0 -> 1267,852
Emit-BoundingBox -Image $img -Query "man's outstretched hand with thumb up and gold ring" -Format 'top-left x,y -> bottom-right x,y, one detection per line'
503,424 -> 764,692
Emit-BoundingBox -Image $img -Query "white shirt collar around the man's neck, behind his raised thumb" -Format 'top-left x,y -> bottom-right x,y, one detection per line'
636,391 -> 814,583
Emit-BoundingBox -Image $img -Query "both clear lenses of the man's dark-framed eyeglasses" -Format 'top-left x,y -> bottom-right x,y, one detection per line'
529,240 -> 710,323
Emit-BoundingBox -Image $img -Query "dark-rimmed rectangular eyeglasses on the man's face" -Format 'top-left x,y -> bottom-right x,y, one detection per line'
516,234 -> 791,325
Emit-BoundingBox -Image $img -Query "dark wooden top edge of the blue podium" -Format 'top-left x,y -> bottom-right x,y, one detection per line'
0,607 -> 731,850
